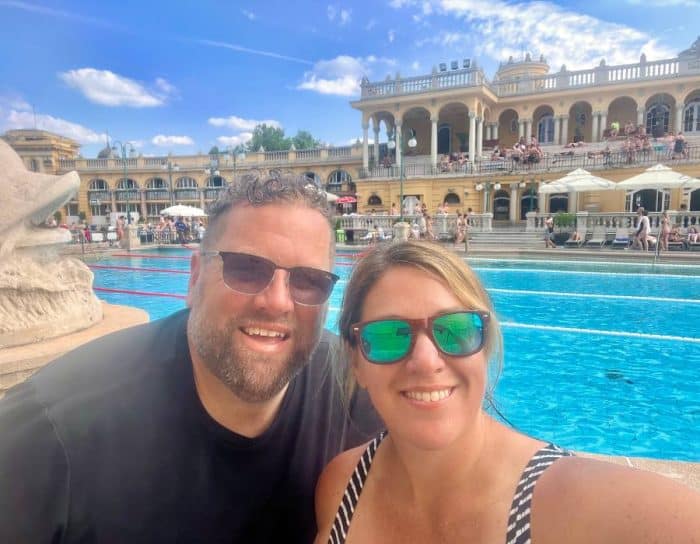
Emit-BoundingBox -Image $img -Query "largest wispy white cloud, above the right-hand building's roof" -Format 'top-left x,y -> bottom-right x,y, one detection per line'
404,0 -> 680,70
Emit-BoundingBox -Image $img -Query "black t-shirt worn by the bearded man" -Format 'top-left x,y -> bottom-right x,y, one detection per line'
0,311 -> 379,543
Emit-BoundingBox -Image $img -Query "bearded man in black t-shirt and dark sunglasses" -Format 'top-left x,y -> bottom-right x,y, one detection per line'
0,170 -> 379,543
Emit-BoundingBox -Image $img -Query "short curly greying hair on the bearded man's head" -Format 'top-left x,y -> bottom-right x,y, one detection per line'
202,170 -> 333,249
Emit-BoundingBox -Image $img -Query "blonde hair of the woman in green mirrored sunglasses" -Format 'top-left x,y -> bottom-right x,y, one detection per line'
338,240 -> 503,402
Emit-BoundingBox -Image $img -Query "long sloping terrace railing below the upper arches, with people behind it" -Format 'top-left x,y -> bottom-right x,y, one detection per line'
359,144 -> 700,179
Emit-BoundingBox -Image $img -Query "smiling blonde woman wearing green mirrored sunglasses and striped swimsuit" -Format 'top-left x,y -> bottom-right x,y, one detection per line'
316,241 -> 700,544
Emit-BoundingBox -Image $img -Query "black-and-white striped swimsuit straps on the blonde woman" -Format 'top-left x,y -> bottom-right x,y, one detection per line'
328,432 -> 573,544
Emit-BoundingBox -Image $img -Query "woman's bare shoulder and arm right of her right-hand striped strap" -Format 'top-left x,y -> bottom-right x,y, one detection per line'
532,457 -> 700,543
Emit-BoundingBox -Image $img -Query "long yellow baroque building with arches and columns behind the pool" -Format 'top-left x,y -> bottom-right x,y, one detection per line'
3,38 -> 700,225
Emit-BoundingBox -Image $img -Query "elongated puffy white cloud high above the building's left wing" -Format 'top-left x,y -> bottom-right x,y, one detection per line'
59,68 -> 175,108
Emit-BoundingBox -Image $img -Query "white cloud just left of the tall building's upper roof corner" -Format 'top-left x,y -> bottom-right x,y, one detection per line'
297,55 -> 396,96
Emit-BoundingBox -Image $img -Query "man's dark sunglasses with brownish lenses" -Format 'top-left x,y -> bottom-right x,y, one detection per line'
202,251 -> 338,306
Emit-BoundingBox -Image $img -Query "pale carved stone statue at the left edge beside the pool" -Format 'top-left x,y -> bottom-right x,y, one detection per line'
0,140 -> 102,348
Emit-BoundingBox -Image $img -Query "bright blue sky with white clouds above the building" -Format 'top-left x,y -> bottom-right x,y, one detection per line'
0,0 -> 700,157
